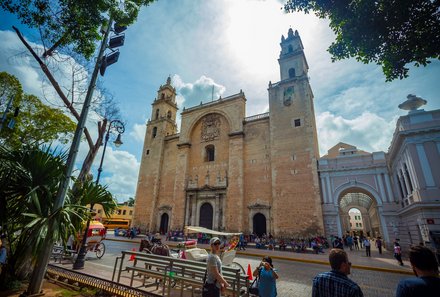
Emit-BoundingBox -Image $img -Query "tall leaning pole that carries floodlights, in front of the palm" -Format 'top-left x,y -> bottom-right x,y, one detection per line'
24,17 -> 113,296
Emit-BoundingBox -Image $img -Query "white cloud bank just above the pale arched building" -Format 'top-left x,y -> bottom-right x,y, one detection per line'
316,111 -> 397,155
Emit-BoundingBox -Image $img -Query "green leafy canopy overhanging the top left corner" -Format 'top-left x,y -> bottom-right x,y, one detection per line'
0,0 -> 153,59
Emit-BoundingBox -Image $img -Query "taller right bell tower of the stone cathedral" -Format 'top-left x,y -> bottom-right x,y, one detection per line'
268,29 -> 323,234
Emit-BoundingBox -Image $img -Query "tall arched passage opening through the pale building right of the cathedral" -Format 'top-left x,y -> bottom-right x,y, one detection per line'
339,188 -> 383,237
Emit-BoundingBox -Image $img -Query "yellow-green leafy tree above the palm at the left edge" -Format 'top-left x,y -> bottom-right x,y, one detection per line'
0,72 -> 75,149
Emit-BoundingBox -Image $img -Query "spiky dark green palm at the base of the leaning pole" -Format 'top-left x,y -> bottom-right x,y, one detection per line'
0,145 -> 117,288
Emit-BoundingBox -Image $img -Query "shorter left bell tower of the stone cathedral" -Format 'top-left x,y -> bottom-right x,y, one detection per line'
134,77 -> 178,230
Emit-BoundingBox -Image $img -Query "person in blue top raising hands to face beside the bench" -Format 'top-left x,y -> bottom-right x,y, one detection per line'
253,256 -> 278,297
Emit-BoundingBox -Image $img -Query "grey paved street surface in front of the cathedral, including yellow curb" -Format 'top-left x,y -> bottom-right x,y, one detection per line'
49,234 -> 412,297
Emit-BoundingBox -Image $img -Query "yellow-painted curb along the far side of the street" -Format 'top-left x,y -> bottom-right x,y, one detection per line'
105,238 -> 414,275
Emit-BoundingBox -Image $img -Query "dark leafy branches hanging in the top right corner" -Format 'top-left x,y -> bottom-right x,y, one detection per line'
284,0 -> 440,81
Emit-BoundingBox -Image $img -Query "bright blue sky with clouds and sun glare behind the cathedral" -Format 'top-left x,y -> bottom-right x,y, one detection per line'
0,0 -> 440,201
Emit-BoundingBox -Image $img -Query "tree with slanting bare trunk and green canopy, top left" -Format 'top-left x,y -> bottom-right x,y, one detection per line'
0,0 -> 153,179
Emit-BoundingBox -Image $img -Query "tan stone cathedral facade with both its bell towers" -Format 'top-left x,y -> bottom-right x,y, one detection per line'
133,29 -> 324,235
